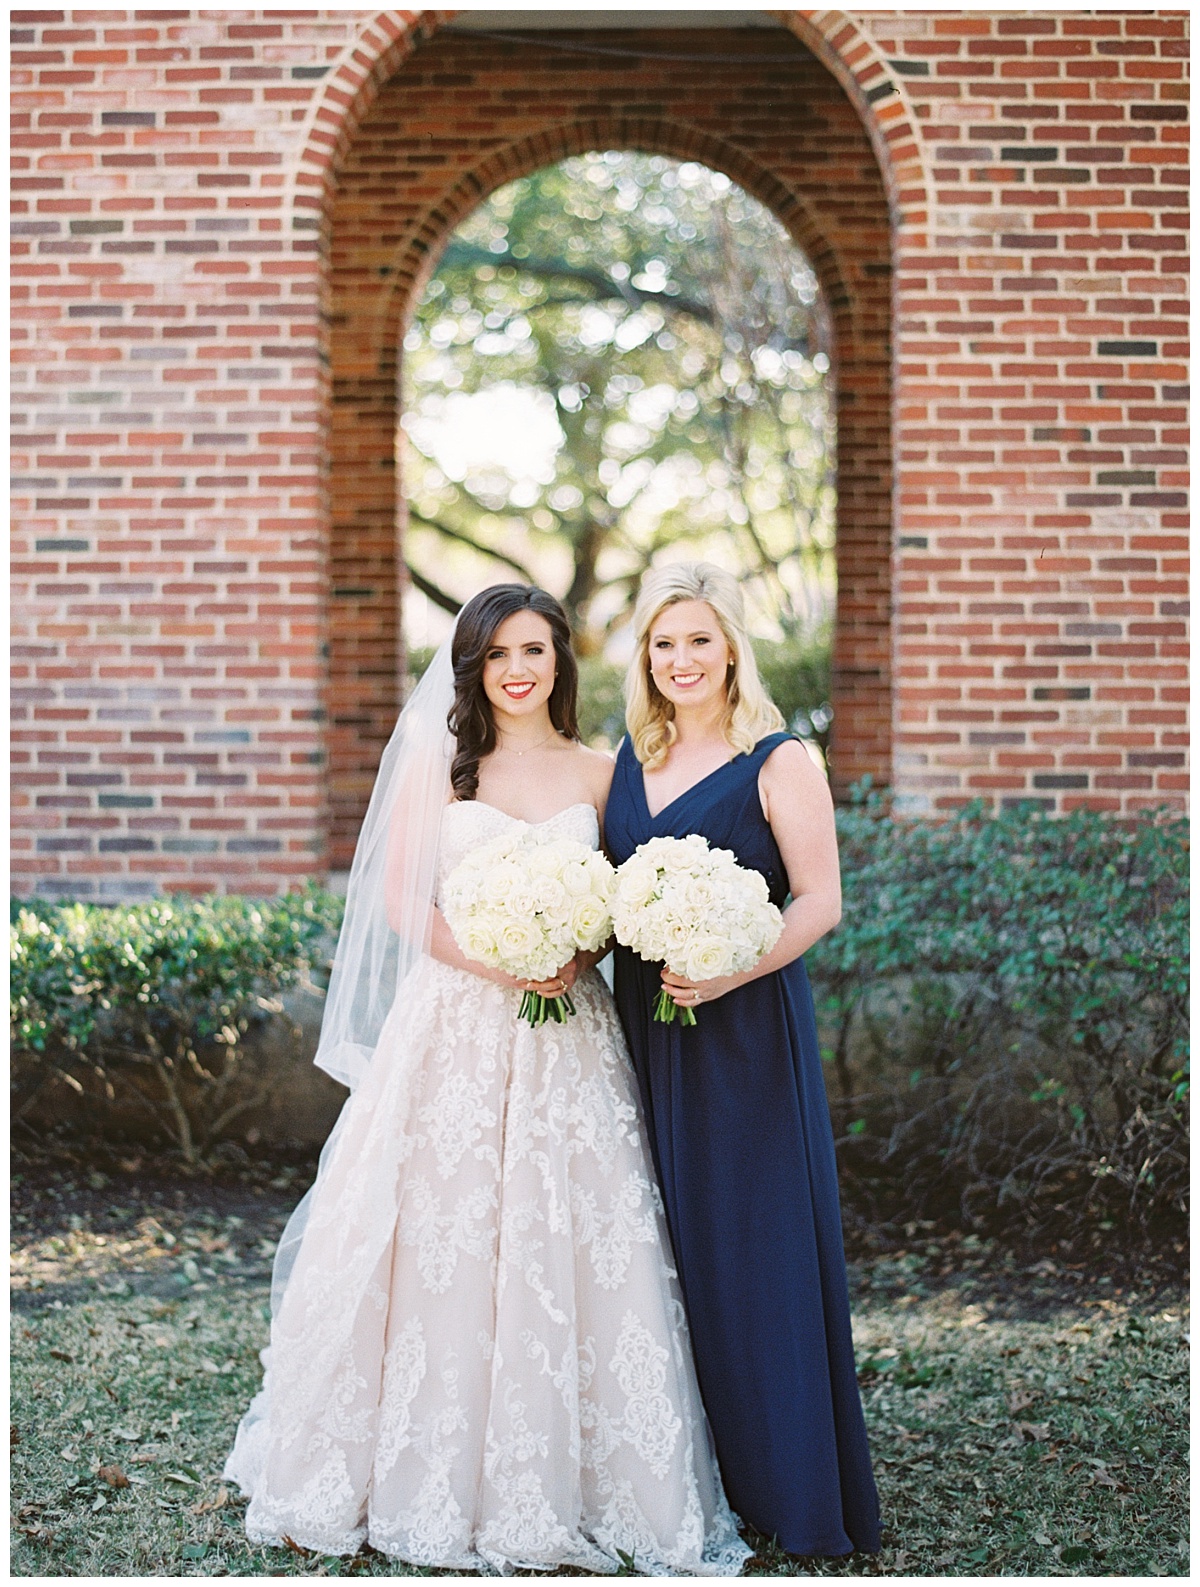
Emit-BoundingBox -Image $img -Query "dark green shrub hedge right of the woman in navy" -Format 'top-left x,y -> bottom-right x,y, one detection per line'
808,803 -> 1187,1224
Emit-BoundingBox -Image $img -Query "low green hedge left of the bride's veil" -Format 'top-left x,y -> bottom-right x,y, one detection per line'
10,890 -> 341,1162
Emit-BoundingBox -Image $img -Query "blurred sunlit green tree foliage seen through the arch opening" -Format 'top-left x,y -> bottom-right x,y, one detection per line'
403,152 -> 835,654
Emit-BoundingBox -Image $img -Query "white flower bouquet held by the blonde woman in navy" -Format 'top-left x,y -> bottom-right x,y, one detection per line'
613,833 -> 783,1025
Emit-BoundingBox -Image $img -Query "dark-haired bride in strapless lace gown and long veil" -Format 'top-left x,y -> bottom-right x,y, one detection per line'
225,584 -> 749,1576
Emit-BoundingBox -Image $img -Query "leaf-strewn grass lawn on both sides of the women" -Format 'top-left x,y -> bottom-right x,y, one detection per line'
11,1163 -> 1189,1576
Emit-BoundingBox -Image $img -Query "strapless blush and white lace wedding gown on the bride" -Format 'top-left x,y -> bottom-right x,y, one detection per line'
225,801 -> 749,1576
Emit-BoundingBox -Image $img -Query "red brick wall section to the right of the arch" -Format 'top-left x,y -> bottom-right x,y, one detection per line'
871,11 -> 1187,811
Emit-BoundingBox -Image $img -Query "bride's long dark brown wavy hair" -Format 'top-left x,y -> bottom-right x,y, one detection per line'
446,584 -> 579,800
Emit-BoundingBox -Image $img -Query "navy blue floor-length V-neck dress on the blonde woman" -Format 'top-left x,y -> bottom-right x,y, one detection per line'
605,733 -> 879,1555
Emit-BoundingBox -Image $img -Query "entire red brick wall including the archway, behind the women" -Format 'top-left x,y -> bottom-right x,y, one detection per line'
13,11 -> 1187,895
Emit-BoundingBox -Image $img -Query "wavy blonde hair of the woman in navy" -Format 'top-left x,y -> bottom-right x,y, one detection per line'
625,562 -> 784,771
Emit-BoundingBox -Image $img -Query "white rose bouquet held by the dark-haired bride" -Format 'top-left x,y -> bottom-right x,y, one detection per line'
441,830 -> 616,1025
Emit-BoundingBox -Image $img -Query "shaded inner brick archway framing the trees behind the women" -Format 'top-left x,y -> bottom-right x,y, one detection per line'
319,14 -> 898,868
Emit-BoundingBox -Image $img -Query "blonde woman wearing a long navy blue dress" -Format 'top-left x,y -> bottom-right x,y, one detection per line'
605,562 -> 879,1555
